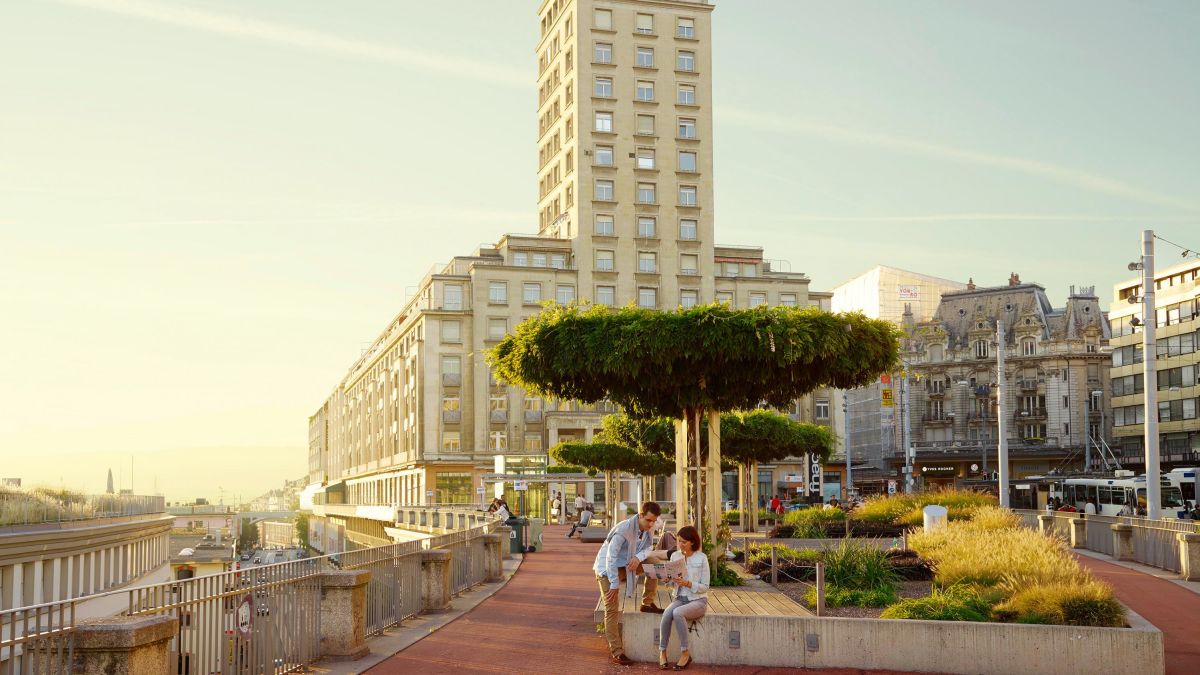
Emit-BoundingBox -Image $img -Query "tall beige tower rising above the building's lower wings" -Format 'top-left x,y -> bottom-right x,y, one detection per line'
538,0 -> 714,307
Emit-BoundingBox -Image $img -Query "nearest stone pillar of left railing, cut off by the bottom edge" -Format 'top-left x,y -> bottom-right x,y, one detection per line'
71,616 -> 179,675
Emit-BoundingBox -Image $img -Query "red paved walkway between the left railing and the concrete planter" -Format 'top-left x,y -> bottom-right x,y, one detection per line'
370,526 -> 940,675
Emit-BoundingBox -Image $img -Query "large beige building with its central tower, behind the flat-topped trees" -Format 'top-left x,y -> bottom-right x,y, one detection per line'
301,0 -> 832,548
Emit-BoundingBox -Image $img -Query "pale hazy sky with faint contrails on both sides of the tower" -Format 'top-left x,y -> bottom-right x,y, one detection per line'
0,0 -> 1200,501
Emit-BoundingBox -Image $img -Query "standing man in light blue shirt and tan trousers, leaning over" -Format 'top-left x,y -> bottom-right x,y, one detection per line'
592,502 -> 662,665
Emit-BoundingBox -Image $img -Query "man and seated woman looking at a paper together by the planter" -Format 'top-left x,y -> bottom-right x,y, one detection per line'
593,502 -> 709,670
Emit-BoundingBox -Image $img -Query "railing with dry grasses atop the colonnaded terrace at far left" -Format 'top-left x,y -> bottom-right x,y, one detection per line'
0,490 -> 167,527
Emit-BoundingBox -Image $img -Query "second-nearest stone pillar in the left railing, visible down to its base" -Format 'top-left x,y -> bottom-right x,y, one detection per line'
320,569 -> 371,661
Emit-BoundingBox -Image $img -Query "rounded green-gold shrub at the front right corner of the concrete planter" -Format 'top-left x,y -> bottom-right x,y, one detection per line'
994,580 -> 1126,627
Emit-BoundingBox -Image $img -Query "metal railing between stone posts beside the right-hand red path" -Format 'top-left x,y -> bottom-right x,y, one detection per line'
1016,510 -> 1200,572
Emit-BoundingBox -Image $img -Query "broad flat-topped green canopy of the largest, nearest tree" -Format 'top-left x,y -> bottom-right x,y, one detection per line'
487,304 -> 899,418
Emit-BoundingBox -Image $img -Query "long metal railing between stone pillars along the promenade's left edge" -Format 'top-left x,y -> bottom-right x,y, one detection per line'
0,506 -> 499,675
